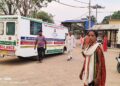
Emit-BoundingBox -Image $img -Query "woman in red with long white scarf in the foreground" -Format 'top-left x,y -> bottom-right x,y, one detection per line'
80,31 -> 106,86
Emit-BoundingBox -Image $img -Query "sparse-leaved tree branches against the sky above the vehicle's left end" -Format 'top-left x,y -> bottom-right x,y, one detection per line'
0,0 -> 52,16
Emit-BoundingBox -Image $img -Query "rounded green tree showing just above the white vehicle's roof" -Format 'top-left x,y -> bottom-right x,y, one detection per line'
32,11 -> 54,23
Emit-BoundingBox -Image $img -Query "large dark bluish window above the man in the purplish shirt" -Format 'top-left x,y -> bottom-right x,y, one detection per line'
30,21 -> 42,35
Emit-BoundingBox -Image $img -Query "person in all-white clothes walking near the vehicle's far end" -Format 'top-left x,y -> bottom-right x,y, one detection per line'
65,32 -> 76,61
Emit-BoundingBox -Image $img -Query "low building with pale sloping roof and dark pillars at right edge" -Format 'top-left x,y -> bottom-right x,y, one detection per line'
92,22 -> 120,47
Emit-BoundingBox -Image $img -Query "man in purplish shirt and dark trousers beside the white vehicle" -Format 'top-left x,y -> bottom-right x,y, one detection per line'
34,31 -> 46,62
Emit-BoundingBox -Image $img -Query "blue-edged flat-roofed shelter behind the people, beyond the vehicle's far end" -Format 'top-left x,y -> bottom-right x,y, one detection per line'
62,18 -> 95,38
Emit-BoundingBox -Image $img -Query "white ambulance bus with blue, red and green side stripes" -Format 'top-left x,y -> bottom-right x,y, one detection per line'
0,15 -> 68,57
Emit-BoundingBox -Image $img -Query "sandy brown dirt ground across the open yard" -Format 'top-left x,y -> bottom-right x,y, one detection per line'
0,42 -> 120,86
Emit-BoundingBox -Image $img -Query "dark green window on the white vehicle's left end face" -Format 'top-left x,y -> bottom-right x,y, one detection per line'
6,22 -> 15,35
